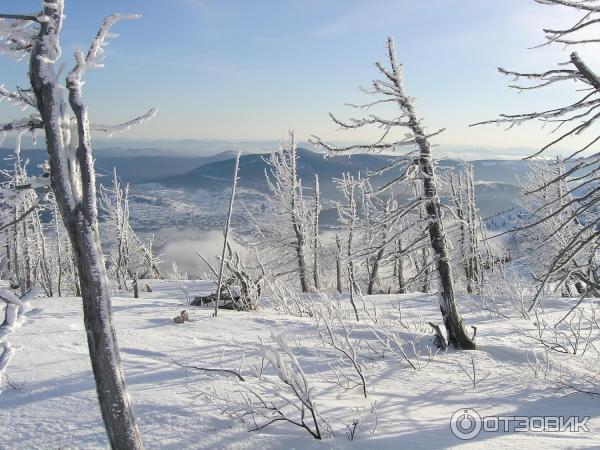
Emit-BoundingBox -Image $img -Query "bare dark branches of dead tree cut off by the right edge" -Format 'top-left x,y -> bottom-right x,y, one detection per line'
472,0 -> 600,310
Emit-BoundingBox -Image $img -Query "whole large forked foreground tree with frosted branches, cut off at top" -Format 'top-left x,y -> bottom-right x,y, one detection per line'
0,0 -> 154,449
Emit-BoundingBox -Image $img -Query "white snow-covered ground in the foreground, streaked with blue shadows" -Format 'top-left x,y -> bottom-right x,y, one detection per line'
0,281 -> 600,449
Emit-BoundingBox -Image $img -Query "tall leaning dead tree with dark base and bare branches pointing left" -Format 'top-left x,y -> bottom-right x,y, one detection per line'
312,38 -> 475,349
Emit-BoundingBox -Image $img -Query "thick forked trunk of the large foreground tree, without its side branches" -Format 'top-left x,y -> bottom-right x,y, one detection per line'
29,0 -> 143,449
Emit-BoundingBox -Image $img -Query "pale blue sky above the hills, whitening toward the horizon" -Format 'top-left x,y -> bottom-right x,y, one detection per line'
0,0 -> 598,156
